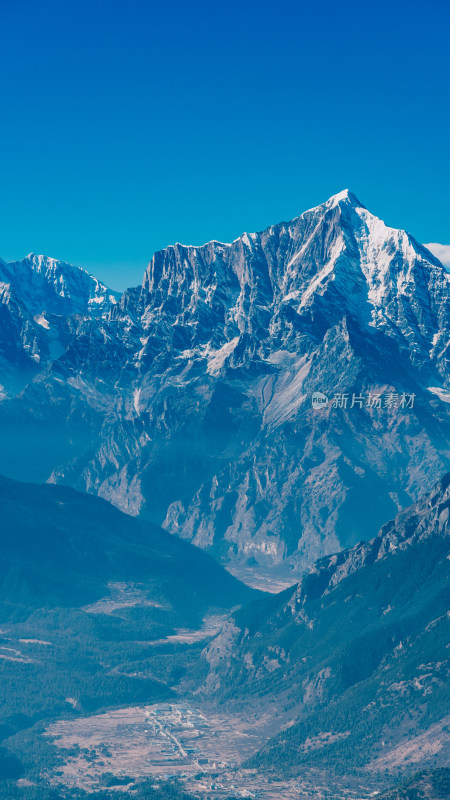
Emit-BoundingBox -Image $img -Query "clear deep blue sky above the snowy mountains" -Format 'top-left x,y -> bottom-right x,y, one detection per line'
0,0 -> 450,288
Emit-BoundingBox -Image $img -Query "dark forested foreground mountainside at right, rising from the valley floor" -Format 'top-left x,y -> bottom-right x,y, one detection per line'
200,475 -> 450,775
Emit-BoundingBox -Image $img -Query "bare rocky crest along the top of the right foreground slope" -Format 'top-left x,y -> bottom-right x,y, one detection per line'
203,474 -> 450,691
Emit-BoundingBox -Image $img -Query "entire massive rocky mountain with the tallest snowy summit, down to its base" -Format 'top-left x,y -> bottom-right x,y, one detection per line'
0,191 -> 450,574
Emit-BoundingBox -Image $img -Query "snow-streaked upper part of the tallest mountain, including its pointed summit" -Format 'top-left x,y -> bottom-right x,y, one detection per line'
141,189 -> 448,378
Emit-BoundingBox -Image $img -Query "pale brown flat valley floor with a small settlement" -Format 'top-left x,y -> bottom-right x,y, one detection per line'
46,702 -> 380,800
